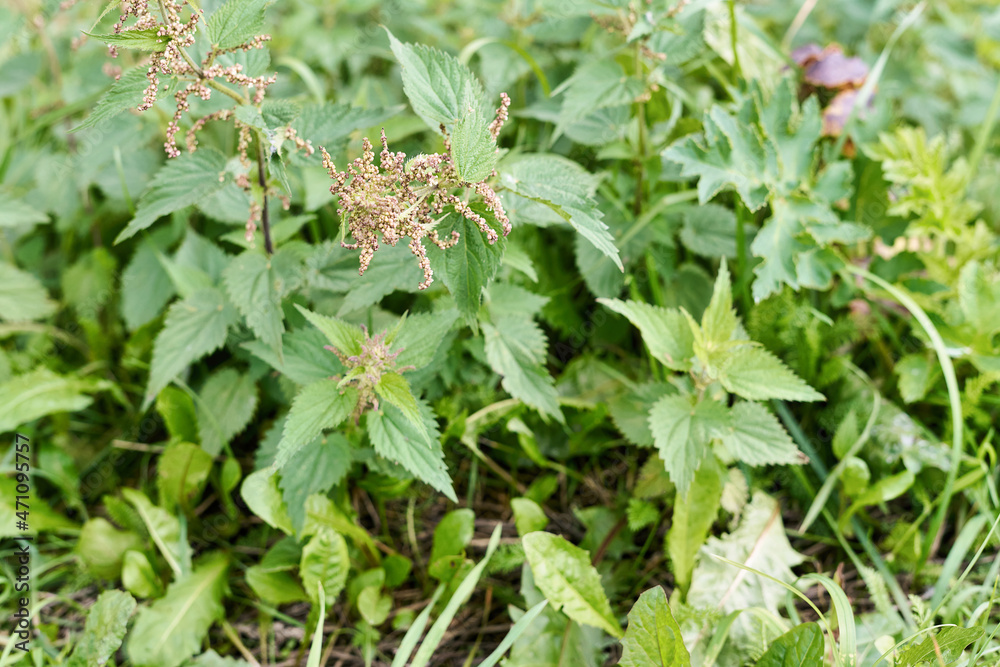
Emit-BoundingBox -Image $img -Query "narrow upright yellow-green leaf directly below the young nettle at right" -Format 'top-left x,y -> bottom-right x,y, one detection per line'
667,457 -> 722,593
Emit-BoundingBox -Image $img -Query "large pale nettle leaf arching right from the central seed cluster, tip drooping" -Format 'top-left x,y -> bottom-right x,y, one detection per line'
501,154 -> 625,271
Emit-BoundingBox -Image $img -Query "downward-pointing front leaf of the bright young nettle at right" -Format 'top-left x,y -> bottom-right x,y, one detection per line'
649,396 -> 729,496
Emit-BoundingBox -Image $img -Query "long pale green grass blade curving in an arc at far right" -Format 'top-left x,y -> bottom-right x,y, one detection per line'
847,264 -> 964,572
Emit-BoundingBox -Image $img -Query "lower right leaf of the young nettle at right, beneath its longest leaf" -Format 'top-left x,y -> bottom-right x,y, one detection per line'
720,401 -> 807,466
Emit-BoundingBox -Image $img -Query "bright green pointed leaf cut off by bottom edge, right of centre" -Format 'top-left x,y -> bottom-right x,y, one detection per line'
618,586 -> 688,667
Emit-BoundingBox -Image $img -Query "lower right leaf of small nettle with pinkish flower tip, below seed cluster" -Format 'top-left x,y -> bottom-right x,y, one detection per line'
365,401 -> 457,502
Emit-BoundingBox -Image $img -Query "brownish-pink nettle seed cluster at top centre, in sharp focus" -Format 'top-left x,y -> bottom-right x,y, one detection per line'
320,93 -> 511,289
